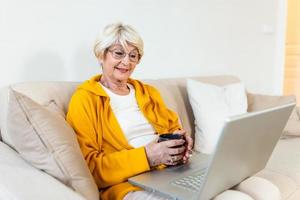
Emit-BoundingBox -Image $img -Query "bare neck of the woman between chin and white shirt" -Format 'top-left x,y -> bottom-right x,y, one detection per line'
100,75 -> 129,94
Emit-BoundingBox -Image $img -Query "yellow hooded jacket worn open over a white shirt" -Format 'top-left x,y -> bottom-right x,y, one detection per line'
67,75 -> 180,200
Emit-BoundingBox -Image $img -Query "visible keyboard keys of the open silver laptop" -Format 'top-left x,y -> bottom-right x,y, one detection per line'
171,169 -> 206,192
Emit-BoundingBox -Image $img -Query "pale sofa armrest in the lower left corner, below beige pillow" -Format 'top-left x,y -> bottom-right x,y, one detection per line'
0,142 -> 85,200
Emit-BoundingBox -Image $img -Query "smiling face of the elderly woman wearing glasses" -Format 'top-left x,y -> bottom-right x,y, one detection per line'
99,44 -> 139,82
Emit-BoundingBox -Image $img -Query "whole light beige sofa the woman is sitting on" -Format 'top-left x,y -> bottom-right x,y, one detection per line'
0,76 -> 300,200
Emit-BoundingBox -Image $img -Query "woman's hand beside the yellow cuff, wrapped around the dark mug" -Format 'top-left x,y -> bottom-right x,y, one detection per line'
145,139 -> 185,167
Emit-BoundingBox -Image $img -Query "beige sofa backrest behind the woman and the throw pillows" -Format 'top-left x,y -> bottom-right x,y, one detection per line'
0,76 -> 239,141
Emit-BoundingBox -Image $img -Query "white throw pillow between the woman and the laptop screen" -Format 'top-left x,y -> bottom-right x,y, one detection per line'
187,79 -> 247,154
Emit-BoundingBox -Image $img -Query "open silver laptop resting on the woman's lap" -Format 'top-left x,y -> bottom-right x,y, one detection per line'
129,103 -> 295,200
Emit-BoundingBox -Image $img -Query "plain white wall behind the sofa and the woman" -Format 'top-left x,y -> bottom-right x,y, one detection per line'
0,0 -> 285,94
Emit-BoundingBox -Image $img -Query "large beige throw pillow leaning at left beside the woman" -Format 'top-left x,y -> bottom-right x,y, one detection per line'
7,90 -> 99,200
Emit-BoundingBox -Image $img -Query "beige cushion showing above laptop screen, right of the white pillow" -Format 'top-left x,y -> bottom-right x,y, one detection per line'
247,93 -> 296,112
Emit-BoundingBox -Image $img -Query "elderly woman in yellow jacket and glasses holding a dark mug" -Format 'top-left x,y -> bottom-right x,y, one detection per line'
67,23 -> 193,200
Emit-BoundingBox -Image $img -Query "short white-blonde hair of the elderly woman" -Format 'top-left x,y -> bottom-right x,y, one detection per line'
94,22 -> 144,59
